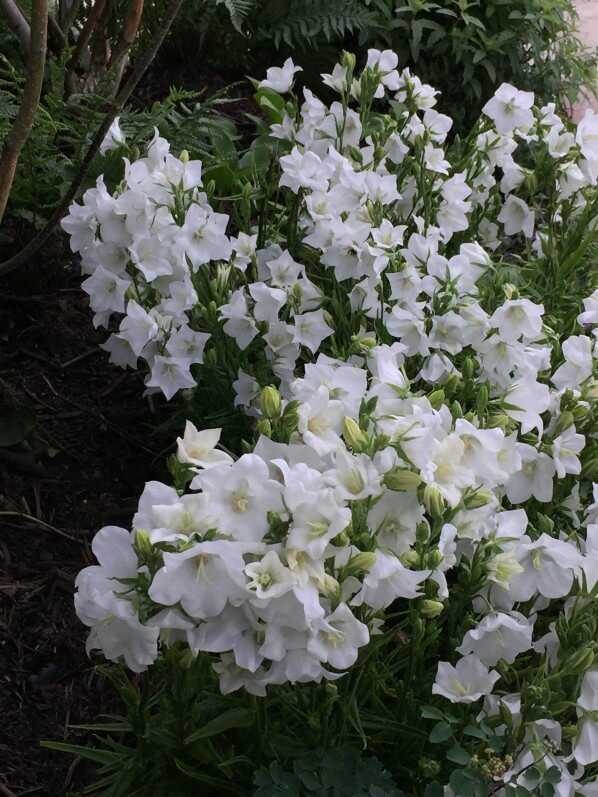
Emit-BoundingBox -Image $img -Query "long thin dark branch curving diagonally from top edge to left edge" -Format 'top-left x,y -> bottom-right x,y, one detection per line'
0,0 -> 183,275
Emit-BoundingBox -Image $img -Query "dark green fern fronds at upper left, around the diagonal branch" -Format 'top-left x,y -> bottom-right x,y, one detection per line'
0,44 -> 236,254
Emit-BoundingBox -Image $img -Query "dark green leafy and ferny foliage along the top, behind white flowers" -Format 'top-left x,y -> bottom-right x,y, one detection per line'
155,0 -> 596,126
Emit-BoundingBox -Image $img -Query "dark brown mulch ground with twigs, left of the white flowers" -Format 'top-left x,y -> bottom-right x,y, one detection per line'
0,268 -> 165,797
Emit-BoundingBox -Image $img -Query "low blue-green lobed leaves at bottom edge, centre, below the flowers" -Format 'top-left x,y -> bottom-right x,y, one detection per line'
254,747 -> 404,797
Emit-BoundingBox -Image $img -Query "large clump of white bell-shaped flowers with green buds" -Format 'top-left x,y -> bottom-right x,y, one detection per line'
64,50 -> 598,795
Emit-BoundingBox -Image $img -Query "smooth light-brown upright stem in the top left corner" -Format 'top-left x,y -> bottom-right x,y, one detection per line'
0,0 -> 48,222
